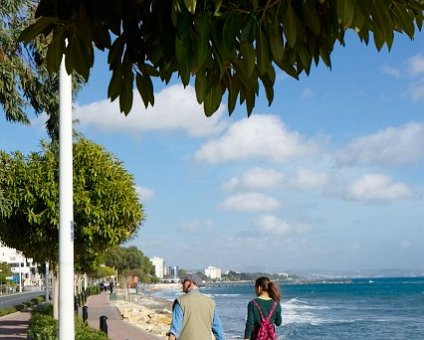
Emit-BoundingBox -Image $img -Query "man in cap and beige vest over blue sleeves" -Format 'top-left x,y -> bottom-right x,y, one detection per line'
166,274 -> 225,340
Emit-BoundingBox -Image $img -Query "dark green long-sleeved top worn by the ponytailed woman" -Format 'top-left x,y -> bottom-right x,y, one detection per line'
244,298 -> 282,339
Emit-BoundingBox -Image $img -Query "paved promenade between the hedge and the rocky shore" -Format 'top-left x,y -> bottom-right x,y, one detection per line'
85,292 -> 164,340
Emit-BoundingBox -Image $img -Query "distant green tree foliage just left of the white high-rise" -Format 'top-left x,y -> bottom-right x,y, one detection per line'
105,246 -> 155,282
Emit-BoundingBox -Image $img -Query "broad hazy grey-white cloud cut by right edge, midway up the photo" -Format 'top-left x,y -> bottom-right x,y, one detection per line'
336,123 -> 424,165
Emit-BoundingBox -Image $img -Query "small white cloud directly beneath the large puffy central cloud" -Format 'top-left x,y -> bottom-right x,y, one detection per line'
222,167 -> 283,191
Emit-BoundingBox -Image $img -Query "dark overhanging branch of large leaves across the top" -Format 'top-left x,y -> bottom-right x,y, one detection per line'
21,0 -> 424,116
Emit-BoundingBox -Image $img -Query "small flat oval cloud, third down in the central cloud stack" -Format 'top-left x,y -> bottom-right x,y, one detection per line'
221,192 -> 279,212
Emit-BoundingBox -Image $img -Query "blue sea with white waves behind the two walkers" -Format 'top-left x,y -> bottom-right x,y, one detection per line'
150,277 -> 424,340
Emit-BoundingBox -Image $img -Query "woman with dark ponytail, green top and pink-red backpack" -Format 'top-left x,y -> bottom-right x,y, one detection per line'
244,276 -> 282,340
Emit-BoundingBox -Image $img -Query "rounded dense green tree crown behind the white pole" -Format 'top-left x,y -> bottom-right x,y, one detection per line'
0,137 -> 143,272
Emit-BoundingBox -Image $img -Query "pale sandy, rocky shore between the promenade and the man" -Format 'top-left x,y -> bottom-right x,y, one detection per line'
112,283 -> 181,339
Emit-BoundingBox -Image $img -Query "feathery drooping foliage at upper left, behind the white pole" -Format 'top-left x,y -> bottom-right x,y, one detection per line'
0,0 -> 82,137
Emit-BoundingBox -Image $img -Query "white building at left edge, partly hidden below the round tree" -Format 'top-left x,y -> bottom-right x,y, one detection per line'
0,243 -> 42,288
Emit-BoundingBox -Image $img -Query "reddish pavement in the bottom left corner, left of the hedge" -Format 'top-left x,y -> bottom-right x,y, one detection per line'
0,312 -> 31,340
